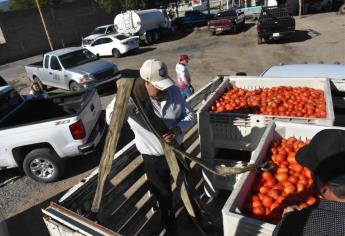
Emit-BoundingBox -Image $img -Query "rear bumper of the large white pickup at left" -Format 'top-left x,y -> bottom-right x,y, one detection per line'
78,112 -> 105,155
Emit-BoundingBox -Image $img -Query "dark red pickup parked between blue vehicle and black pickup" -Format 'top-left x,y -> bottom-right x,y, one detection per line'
207,8 -> 245,35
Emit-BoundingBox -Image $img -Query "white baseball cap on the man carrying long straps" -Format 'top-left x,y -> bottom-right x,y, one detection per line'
140,59 -> 174,91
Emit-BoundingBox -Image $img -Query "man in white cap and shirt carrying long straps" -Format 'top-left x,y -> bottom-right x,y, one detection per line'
106,59 -> 195,230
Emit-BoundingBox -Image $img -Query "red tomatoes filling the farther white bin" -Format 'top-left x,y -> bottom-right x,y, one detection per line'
211,86 -> 327,118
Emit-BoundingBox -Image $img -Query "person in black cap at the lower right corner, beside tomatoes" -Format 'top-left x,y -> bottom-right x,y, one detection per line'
273,129 -> 345,236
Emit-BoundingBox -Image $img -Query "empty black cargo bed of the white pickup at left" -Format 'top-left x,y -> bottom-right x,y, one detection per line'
0,90 -> 95,129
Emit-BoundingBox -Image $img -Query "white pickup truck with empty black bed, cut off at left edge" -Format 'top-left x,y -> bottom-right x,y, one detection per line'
0,82 -> 105,182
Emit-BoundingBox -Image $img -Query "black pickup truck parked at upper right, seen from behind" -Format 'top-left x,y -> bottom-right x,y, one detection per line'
257,6 -> 295,44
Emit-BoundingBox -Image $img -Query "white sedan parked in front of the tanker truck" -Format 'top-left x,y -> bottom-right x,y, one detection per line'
83,34 -> 139,57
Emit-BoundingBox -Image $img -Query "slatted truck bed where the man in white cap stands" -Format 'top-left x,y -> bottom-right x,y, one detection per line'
42,79 -> 226,235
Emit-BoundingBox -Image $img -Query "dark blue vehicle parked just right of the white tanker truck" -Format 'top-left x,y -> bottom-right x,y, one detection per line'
173,10 -> 215,27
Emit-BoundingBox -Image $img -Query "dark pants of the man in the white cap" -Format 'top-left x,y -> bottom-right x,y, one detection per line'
142,154 -> 175,225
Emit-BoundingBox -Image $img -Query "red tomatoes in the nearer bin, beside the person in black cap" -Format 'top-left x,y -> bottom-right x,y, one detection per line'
243,137 -> 316,224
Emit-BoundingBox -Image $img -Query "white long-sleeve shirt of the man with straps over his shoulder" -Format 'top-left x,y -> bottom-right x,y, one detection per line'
106,85 -> 196,156
